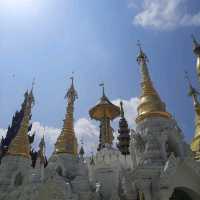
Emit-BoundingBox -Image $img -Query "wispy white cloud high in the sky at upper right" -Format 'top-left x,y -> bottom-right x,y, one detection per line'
132,0 -> 200,30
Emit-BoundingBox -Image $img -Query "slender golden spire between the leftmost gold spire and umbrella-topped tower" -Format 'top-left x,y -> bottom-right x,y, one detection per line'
55,77 -> 78,155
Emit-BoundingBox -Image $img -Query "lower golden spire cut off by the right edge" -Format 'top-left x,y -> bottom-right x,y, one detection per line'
186,72 -> 200,160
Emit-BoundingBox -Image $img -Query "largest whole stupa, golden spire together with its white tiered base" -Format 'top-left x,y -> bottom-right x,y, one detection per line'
130,46 -> 195,200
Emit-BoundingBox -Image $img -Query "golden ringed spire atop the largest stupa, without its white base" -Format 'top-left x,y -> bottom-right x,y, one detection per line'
136,41 -> 171,123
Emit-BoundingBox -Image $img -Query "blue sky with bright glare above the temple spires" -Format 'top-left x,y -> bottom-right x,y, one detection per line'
0,0 -> 200,153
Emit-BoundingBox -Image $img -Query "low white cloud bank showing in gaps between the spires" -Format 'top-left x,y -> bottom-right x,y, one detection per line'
0,98 -> 138,157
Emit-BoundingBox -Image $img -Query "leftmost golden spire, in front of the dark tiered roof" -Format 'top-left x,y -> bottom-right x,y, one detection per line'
7,87 -> 35,158
